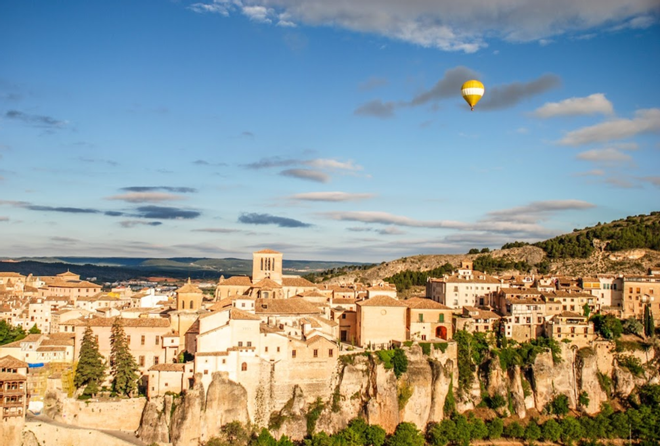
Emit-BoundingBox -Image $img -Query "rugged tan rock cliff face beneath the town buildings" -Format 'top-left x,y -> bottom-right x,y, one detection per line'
138,342 -> 657,446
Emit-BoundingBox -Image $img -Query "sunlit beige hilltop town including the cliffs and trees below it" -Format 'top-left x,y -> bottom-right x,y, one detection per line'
0,215 -> 660,446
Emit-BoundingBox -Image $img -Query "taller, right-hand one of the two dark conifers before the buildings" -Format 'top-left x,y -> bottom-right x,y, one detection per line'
110,317 -> 139,396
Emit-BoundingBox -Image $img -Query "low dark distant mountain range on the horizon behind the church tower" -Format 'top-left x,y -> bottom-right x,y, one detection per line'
0,257 -> 359,282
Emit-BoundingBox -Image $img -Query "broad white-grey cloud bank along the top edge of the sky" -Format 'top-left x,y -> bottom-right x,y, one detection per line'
183,0 -> 659,53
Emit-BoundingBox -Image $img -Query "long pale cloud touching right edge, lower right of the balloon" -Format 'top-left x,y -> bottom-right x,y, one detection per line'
559,108 -> 660,146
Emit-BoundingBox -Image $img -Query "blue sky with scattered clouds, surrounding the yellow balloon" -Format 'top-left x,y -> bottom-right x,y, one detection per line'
0,0 -> 660,262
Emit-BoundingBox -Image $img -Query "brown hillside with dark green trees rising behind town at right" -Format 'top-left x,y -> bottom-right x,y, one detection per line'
316,212 -> 660,293
